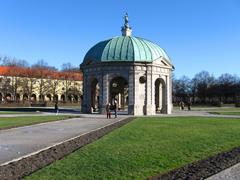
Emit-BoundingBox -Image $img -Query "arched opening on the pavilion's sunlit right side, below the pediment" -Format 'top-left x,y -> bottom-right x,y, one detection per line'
155,78 -> 166,113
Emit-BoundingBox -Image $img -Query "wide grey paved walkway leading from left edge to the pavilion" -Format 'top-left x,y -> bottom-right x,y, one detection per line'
0,115 -> 126,165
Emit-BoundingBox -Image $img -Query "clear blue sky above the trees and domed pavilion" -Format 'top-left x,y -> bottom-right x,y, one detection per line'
0,0 -> 240,77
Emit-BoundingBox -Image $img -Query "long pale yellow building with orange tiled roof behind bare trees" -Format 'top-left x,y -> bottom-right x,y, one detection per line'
0,66 -> 82,104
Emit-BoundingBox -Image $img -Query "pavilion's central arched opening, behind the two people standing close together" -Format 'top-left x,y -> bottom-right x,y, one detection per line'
109,77 -> 128,110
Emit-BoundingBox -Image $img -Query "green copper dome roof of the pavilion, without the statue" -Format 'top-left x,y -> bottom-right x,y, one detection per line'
84,36 -> 170,63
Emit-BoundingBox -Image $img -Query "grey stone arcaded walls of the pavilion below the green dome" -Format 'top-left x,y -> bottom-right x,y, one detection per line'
81,58 -> 173,116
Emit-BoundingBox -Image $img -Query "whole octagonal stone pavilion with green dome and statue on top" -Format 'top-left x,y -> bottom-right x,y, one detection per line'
81,14 -> 174,115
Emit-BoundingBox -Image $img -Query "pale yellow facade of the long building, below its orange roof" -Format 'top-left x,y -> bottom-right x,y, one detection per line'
0,75 -> 82,104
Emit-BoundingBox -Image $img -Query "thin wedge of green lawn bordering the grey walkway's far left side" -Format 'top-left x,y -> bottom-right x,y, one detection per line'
0,115 -> 76,130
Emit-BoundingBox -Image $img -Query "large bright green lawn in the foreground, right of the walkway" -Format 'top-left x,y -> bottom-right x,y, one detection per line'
26,117 -> 240,179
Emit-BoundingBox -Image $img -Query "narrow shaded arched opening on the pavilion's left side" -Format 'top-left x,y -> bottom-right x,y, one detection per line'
91,79 -> 100,112
